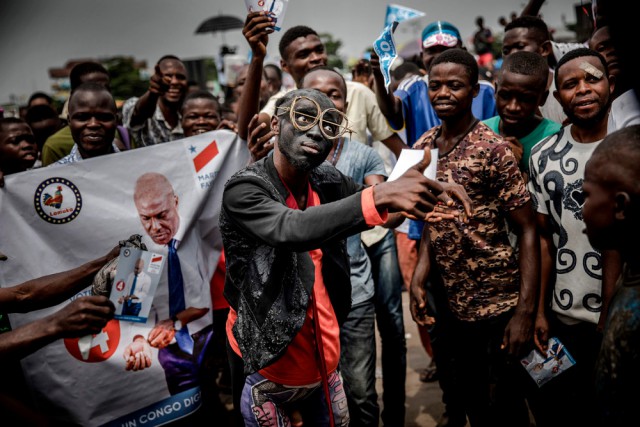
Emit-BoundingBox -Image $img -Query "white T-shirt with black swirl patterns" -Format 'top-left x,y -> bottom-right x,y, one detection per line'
529,125 -> 602,324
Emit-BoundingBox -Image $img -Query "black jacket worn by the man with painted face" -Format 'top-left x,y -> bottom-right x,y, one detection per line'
220,156 -> 368,374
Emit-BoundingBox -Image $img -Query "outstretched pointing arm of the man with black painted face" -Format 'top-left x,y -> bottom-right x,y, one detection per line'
222,150 -> 451,252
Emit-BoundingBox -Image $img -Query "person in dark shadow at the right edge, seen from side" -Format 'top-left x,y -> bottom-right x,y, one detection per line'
582,125 -> 640,426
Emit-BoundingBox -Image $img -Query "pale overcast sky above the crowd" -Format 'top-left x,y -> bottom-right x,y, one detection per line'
0,0 -> 580,104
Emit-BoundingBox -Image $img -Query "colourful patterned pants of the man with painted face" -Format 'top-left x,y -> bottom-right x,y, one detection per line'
240,371 -> 349,427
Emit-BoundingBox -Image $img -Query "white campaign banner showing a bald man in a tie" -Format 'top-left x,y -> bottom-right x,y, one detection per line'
0,130 -> 249,426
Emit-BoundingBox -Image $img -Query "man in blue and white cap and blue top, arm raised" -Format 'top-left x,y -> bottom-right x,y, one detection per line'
371,21 -> 497,147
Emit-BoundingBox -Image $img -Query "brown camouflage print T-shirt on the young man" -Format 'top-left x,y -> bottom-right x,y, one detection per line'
414,123 -> 530,321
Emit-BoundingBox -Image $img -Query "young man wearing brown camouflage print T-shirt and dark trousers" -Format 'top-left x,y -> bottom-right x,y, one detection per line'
411,49 -> 539,426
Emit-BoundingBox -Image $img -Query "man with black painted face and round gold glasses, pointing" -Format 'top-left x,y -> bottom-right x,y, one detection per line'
220,89 -> 460,425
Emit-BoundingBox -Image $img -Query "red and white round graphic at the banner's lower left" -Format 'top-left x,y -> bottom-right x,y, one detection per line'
64,319 -> 120,363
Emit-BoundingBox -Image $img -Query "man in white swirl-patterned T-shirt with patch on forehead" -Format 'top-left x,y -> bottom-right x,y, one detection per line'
529,48 -> 620,426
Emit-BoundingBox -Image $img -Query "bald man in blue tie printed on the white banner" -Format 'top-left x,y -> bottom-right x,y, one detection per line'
124,172 -> 212,395
